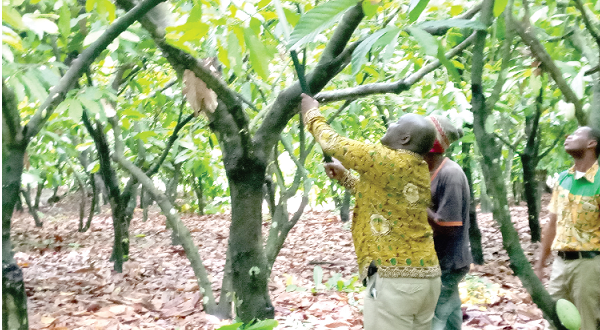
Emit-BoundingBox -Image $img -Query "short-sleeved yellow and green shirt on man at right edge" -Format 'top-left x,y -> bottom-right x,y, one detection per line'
548,162 -> 600,251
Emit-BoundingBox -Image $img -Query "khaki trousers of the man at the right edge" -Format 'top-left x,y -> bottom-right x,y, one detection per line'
548,256 -> 600,330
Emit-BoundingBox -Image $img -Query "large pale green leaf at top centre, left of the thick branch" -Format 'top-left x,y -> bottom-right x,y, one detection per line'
288,0 -> 358,49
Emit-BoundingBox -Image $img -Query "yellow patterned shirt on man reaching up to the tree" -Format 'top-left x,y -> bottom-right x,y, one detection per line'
304,108 -> 441,280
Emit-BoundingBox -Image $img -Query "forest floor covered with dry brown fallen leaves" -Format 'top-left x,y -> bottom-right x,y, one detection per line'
12,196 -> 550,330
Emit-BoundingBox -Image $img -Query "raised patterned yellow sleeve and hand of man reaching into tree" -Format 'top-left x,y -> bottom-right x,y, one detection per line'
304,108 -> 398,175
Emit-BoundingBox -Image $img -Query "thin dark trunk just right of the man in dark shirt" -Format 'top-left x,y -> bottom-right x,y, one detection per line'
462,142 -> 485,265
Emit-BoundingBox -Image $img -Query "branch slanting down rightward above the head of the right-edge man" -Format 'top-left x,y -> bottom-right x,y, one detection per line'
507,16 -> 587,125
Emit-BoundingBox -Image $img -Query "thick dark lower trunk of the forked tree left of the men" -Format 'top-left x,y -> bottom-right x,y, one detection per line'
227,162 -> 275,323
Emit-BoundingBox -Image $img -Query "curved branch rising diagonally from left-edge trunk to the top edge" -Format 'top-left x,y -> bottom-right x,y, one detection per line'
25,0 -> 164,141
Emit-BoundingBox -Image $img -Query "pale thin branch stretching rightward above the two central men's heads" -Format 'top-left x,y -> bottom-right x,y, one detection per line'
315,33 -> 475,103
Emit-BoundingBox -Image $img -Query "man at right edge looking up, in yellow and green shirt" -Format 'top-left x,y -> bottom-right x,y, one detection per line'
535,126 -> 600,330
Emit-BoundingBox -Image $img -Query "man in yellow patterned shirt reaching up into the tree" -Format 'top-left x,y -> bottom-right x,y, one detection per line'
302,94 -> 441,330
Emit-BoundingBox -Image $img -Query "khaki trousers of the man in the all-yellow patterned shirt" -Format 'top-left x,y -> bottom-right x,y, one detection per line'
363,273 -> 442,330
